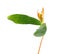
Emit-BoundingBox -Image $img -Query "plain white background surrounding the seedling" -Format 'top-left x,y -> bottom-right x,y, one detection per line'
0,0 -> 60,54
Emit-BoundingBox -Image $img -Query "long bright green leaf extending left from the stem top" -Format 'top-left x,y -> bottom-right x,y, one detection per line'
8,14 -> 41,25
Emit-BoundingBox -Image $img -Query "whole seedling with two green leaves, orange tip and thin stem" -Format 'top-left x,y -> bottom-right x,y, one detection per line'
8,8 -> 47,54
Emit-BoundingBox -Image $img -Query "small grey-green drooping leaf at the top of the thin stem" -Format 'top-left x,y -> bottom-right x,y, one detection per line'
34,23 -> 47,37
